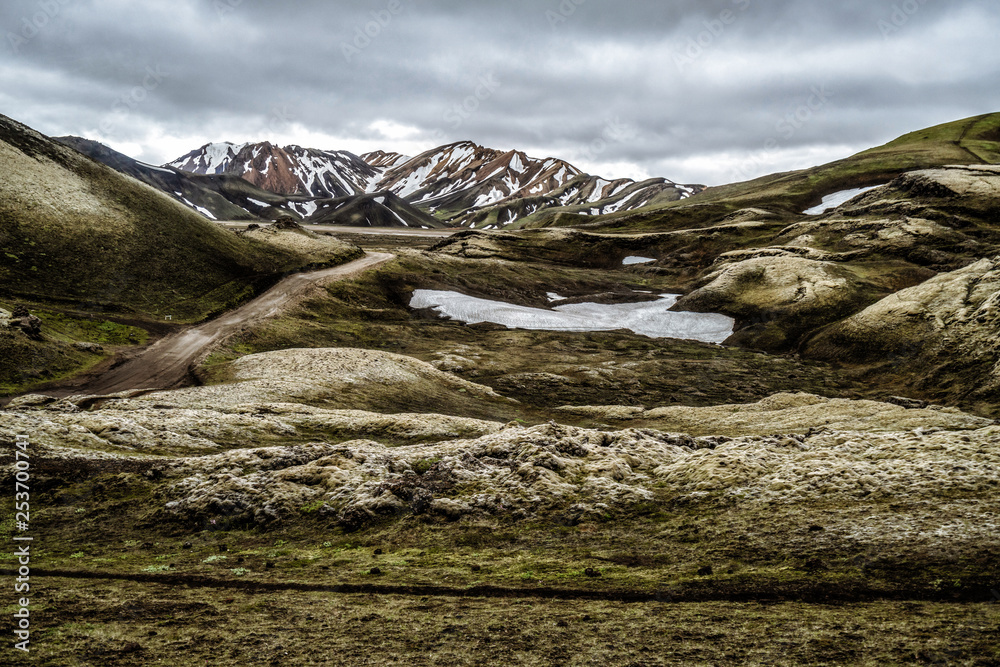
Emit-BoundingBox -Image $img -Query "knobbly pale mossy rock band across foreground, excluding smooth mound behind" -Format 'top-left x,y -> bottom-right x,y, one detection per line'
0,397 -> 1000,539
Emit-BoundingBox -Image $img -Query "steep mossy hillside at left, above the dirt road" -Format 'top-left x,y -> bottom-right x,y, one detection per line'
0,116 -> 336,320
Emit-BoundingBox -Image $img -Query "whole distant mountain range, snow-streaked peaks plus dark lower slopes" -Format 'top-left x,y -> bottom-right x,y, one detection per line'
58,137 -> 704,229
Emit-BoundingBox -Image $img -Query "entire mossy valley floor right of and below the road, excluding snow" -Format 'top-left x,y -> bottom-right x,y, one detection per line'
0,237 -> 1000,666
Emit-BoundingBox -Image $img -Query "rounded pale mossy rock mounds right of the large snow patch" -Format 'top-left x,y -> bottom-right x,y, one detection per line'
663,165 -> 1000,358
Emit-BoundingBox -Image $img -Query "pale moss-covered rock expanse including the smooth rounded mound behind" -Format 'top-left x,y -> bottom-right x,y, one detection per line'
0,350 -> 1000,544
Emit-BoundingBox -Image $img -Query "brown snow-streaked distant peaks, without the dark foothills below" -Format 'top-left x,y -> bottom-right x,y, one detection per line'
165,141 -> 704,228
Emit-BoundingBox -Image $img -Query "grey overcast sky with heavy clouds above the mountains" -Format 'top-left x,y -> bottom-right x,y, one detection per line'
0,0 -> 1000,184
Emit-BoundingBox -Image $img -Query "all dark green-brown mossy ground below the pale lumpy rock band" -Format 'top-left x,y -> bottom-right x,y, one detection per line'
0,446 -> 1000,665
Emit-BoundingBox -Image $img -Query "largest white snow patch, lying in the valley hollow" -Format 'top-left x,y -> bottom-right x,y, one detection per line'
410,290 -> 735,343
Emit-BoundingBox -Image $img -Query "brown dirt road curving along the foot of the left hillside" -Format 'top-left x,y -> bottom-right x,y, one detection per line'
73,253 -> 394,395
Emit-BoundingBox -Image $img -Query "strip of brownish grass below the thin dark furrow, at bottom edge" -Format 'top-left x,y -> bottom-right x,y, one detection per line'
9,578 -> 1000,666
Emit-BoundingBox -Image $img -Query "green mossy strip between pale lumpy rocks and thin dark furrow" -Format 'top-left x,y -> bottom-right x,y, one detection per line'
0,459 -> 1000,602
